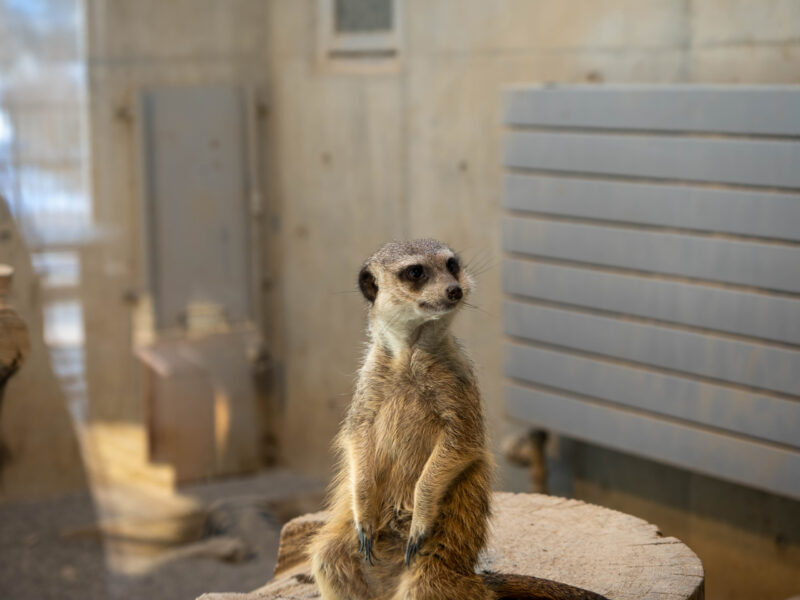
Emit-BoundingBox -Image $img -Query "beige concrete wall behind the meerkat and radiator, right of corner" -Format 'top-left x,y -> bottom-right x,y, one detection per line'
264,0 -> 800,598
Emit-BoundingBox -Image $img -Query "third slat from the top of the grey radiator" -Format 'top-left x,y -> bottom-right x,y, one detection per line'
504,173 -> 800,240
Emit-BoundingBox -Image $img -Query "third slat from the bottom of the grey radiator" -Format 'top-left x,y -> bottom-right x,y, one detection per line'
504,301 -> 800,394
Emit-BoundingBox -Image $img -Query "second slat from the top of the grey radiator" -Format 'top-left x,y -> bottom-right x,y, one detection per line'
505,131 -> 800,188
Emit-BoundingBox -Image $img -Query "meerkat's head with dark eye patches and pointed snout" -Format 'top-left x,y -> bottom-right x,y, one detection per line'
358,239 -> 473,346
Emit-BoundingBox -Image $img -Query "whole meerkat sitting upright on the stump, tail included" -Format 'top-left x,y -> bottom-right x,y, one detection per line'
309,239 -> 602,600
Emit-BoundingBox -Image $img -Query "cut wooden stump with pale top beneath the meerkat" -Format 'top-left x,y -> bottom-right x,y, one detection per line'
201,493 -> 705,600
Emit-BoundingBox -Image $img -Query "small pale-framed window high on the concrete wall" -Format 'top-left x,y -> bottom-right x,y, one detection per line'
319,0 -> 402,67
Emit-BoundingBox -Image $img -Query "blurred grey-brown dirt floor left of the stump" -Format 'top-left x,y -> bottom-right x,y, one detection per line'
0,470 -> 324,600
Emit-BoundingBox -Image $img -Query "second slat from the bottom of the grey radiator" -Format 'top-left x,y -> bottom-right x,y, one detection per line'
506,344 -> 800,448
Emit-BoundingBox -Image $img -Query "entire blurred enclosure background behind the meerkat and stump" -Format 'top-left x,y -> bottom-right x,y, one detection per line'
0,0 -> 800,600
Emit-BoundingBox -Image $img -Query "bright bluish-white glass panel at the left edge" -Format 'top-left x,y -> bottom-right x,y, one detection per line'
0,0 -> 92,432
